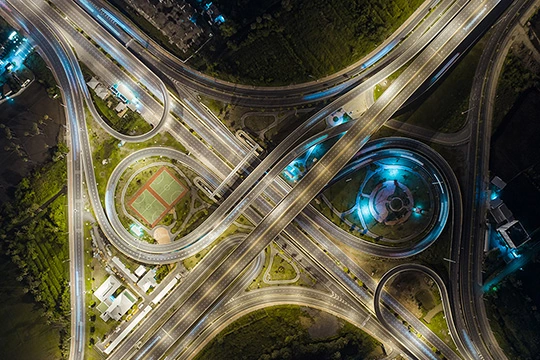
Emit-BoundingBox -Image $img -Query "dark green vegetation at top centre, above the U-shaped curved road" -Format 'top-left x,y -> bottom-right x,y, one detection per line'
192,0 -> 422,85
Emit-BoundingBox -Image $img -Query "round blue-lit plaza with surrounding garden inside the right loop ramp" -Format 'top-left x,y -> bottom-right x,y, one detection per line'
318,143 -> 450,246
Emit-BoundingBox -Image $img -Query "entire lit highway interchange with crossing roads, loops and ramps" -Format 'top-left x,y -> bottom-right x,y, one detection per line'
0,0 -> 534,359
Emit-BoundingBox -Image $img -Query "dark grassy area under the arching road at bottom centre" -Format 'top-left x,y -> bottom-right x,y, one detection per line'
195,306 -> 382,360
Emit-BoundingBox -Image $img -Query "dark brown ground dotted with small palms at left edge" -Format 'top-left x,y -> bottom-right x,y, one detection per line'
0,82 -> 65,202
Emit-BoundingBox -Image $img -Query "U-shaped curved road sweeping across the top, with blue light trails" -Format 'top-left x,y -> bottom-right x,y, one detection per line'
77,0 -> 451,107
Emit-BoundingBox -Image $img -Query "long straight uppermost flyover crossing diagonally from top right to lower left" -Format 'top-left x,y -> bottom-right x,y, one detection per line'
127,3 -> 506,358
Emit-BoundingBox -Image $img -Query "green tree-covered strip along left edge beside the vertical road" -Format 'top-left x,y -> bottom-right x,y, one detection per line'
0,144 -> 71,355
